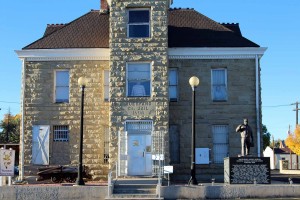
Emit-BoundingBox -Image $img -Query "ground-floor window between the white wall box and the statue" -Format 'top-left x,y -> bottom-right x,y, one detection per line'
212,124 -> 229,164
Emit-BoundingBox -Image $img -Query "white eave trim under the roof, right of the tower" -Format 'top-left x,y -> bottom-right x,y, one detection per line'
168,47 -> 267,59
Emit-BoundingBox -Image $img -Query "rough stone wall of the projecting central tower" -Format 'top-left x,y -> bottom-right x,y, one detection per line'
110,0 -> 169,167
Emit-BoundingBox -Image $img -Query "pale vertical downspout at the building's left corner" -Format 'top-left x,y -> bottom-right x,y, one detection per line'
19,58 -> 26,181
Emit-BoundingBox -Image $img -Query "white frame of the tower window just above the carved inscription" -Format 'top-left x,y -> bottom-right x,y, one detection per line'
126,62 -> 152,97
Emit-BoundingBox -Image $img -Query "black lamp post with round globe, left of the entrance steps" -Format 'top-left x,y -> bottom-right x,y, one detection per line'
76,77 -> 87,185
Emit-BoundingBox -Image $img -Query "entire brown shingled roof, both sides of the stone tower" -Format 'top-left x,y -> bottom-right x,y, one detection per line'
23,9 -> 259,49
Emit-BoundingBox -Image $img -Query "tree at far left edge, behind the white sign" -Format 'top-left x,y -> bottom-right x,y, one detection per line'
0,111 -> 21,144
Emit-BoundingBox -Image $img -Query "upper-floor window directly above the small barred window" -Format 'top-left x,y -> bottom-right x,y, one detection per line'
55,71 -> 69,103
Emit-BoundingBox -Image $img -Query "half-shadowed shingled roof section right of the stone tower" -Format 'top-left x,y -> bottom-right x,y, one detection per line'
169,9 -> 259,47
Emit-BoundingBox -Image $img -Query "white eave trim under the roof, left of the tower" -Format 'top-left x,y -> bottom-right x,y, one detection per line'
15,48 -> 110,61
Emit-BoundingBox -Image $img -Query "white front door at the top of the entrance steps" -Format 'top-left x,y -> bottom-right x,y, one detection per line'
127,134 -> 146,176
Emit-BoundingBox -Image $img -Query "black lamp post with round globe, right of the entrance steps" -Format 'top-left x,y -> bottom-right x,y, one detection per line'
189,76 -> 200,185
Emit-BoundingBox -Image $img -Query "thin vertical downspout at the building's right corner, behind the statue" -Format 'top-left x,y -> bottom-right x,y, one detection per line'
255,55 -> 261,157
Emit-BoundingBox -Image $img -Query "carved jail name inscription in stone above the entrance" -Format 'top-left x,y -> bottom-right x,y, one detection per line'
123,102 -> 156,116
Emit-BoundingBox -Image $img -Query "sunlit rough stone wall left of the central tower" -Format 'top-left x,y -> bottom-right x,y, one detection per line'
24,61 -> 109,179
